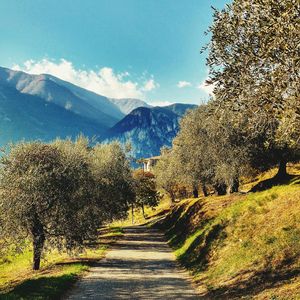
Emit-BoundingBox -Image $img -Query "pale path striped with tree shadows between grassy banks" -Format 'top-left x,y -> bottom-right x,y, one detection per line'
67,226 -> 199,300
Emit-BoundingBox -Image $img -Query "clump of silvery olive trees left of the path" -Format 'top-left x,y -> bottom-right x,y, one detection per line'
0,137 -> 133,269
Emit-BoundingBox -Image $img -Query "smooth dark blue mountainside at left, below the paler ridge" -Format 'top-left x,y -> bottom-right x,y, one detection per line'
0,82 -> 107,145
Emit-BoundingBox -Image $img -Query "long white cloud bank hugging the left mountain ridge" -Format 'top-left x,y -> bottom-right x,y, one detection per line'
13,59 -> 159,99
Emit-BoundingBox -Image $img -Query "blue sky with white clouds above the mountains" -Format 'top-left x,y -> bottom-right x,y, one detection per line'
0,0 -> 230,105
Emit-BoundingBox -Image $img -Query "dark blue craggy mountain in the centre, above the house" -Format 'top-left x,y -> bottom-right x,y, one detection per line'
105,104 -> 196,158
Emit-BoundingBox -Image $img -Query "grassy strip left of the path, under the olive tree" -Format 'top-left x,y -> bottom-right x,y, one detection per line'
0,228 -> 122,299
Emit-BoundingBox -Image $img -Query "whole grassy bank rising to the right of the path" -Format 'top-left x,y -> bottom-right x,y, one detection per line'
157,169 -> 300,299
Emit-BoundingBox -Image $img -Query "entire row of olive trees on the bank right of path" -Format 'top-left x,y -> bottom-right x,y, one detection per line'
156,0 -> 300,195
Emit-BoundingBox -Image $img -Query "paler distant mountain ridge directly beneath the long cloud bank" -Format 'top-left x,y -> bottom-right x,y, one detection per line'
0,68 -> 124,128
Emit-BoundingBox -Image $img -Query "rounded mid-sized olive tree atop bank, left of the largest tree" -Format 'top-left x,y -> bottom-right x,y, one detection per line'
173,101 -> 249,196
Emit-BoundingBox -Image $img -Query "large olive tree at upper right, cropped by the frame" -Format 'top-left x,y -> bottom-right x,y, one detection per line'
207,0 -> 300,176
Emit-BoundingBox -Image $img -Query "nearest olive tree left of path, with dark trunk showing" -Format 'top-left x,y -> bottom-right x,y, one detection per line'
0,142 -> 97,270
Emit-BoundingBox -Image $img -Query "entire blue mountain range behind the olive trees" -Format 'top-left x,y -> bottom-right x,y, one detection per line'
0,67 -> 196,158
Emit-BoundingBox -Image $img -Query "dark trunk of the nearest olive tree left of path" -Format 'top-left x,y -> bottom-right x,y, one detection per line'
32,216 -> 46,270
